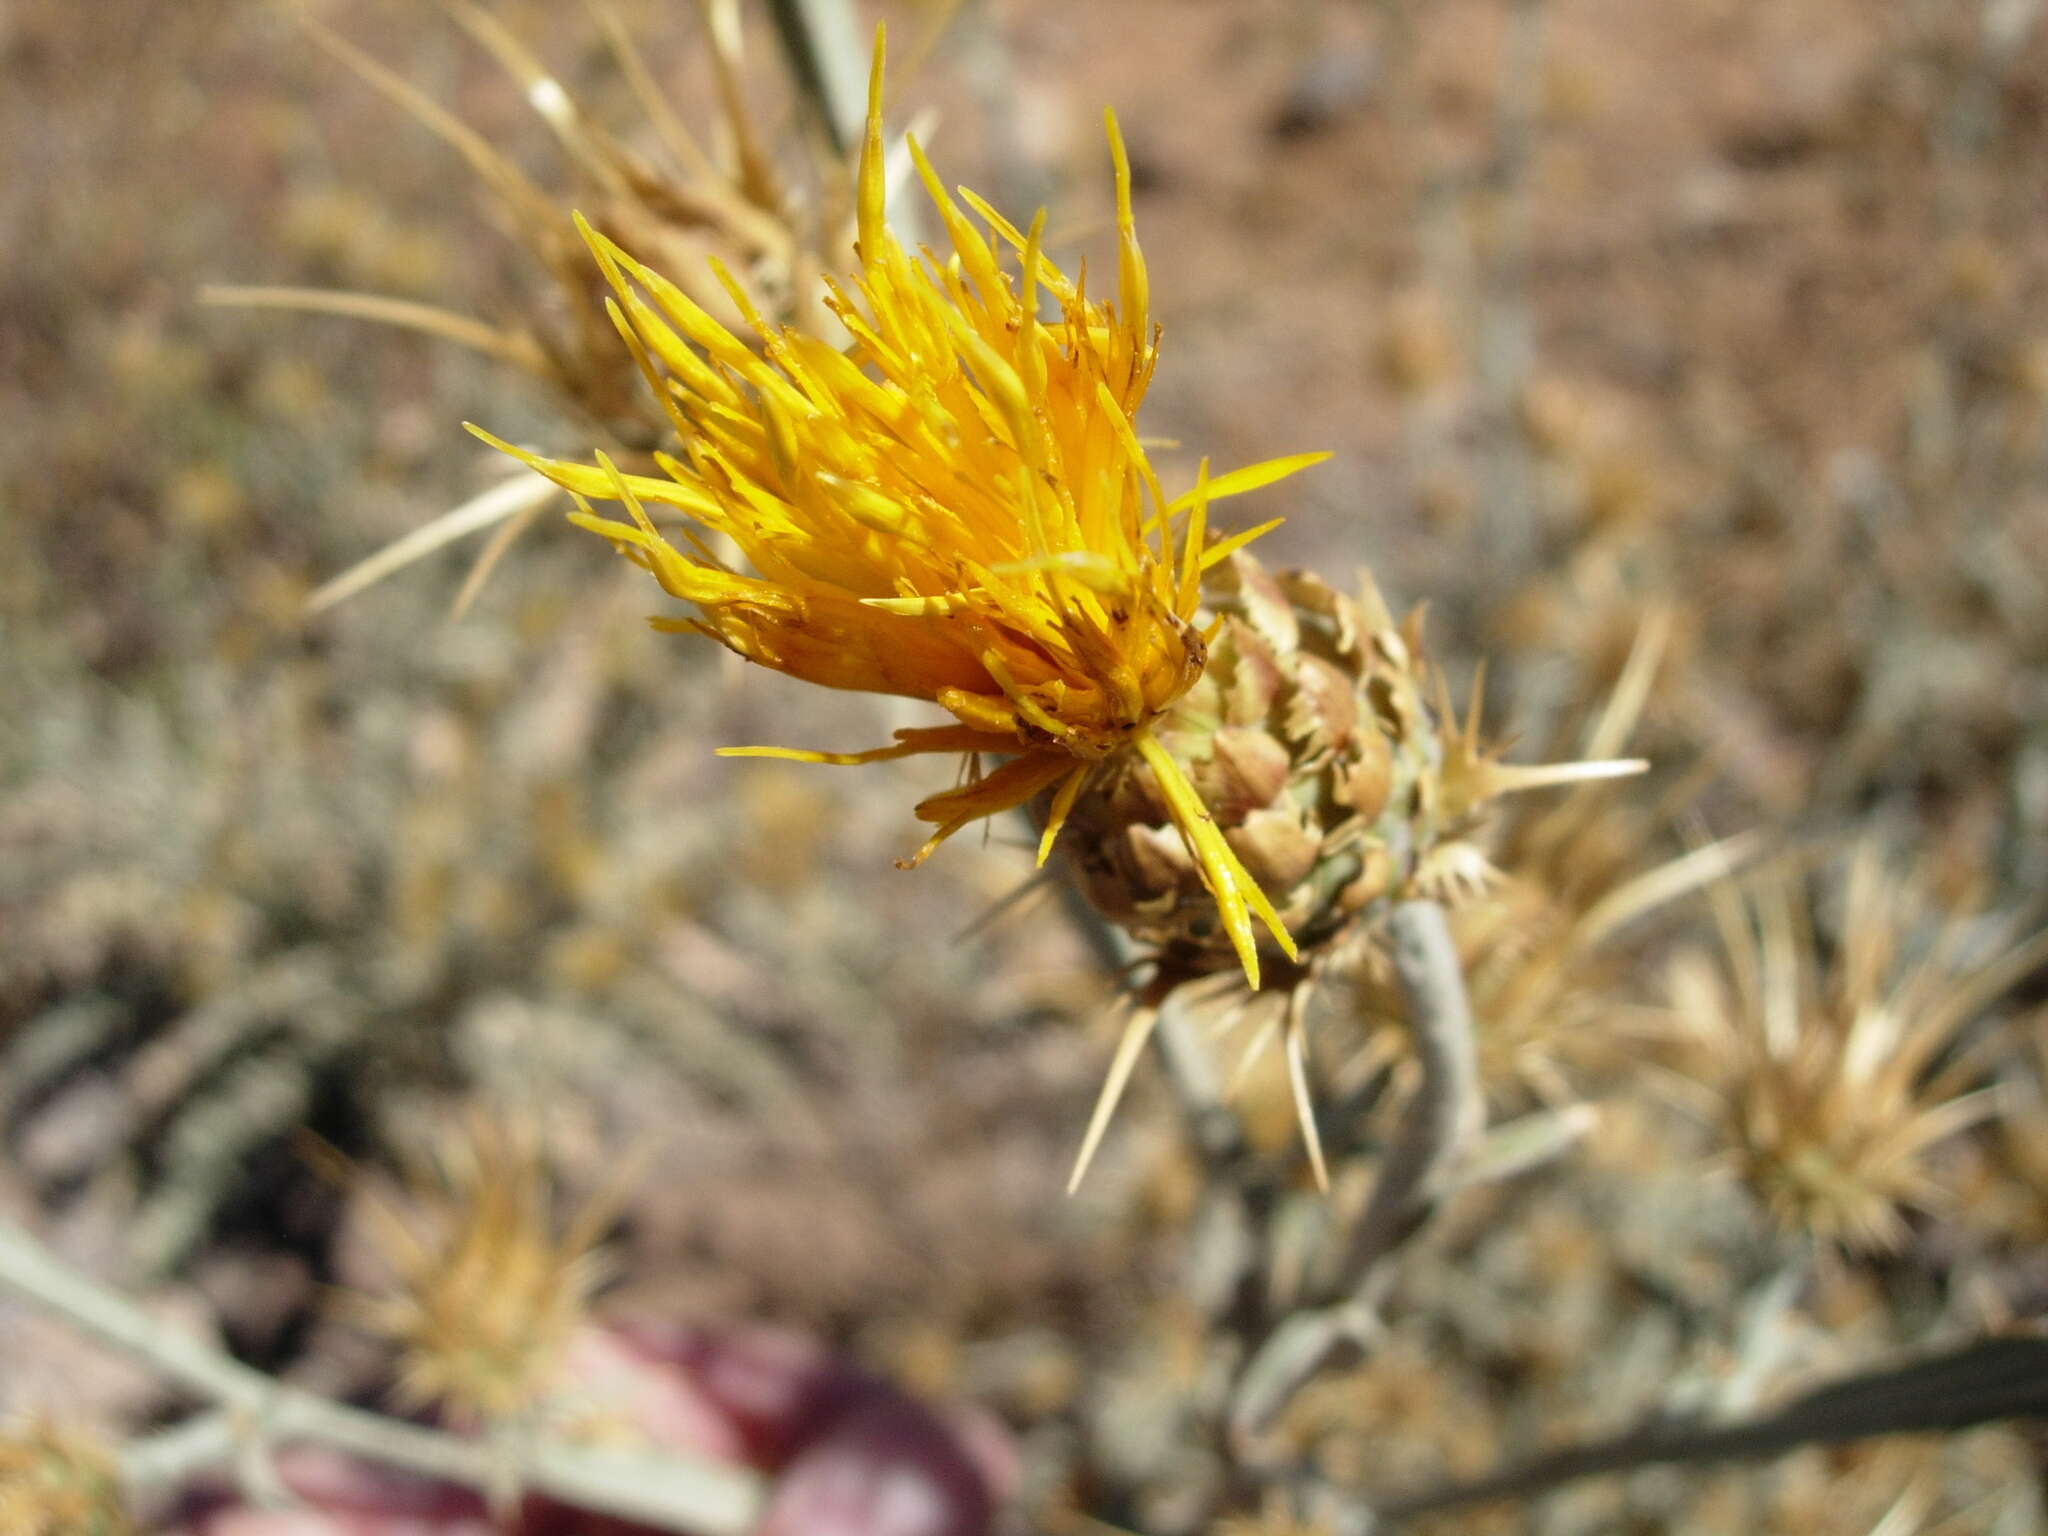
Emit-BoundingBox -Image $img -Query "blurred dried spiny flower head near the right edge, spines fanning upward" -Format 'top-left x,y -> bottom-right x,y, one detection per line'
1671,842 -> 2048,1251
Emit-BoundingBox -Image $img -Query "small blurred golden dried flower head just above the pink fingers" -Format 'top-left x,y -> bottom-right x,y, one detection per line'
335,1112 -> 616,1423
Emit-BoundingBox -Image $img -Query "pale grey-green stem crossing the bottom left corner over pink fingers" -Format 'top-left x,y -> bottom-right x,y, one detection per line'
0,1223 -> 764,1536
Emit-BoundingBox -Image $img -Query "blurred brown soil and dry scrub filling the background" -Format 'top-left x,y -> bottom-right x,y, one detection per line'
0,0 -> 2048,1536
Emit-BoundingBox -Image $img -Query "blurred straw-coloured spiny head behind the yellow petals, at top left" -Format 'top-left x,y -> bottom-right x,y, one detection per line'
201,0 -> 872,610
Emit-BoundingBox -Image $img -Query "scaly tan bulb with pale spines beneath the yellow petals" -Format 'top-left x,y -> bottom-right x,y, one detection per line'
1051,553 -> 1642,1182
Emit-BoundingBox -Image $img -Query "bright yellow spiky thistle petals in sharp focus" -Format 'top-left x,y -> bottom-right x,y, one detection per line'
479,35 -> 1327,985
